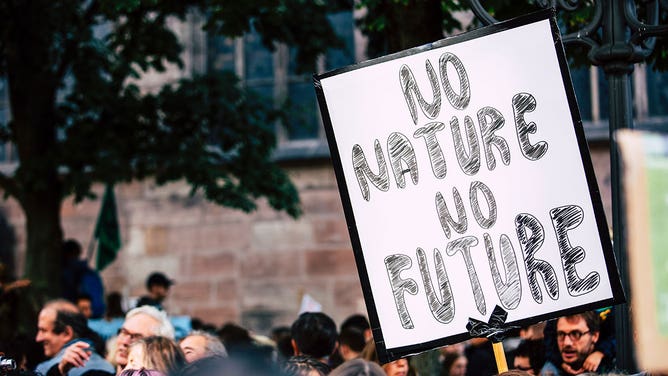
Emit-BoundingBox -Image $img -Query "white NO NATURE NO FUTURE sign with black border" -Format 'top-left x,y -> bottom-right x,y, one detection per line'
315,12 -> 623,361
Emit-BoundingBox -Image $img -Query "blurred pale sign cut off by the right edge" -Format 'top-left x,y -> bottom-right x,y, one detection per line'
616,129 -> 668,374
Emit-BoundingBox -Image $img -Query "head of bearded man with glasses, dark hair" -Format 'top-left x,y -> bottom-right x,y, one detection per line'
557,311 -> 600,369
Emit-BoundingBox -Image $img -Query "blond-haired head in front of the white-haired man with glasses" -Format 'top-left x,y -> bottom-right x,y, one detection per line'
125,336 -> 186,375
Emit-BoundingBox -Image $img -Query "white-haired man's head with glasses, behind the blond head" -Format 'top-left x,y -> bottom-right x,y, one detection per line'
115,306 -> 174,368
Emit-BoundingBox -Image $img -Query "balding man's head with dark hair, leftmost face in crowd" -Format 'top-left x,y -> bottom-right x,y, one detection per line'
35,299 -> 86,358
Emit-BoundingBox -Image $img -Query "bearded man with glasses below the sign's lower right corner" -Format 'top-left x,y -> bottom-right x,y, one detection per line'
556,311 -> 612,375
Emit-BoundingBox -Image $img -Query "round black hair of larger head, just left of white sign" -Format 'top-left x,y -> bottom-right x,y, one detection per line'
290,312 -> 337,358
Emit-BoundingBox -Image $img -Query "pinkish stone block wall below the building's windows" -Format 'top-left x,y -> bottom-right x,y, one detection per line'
1,146 -> 611,333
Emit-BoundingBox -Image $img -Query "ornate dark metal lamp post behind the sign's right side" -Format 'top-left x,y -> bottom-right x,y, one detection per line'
470,0 -> 668,371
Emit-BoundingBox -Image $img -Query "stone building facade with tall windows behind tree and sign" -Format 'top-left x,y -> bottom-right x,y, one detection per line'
0,5 -> 668,334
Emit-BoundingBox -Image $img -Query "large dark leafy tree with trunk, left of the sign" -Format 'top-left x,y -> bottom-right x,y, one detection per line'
0,0 -> 352,332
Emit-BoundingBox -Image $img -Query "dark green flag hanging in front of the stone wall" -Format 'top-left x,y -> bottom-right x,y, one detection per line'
93,184 -> 121,270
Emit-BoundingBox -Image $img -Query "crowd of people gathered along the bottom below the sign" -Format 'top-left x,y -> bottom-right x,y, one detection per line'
0,239 -> 664,376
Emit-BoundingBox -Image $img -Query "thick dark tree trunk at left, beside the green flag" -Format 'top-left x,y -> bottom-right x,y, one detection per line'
3,1 -> 63,331
